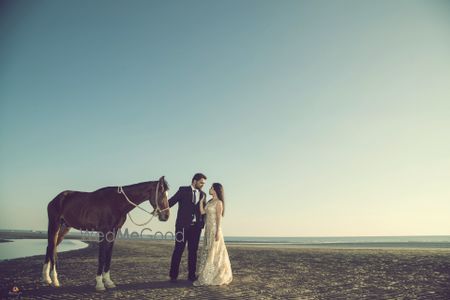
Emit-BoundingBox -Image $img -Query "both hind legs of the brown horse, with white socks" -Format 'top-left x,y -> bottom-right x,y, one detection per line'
42,207 -> 60,287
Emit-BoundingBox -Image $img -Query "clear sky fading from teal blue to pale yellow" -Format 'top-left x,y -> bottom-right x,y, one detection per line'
0,0 -> 450,236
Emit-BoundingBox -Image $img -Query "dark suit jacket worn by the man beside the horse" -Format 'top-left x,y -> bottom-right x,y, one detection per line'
169,186 -> 206,228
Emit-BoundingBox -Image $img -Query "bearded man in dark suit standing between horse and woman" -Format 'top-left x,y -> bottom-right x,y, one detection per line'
169,173 -> 206,282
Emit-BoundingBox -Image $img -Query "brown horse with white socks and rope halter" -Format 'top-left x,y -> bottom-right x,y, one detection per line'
42,176 -> 170,291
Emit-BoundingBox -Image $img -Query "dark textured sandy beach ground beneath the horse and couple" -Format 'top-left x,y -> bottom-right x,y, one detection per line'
0,240 -> 450,299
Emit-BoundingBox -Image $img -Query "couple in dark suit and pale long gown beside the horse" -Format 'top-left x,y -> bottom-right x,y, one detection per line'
169,173 -> 233,286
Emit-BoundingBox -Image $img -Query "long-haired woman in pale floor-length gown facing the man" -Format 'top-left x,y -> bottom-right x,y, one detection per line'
193,183 -> 233,286
